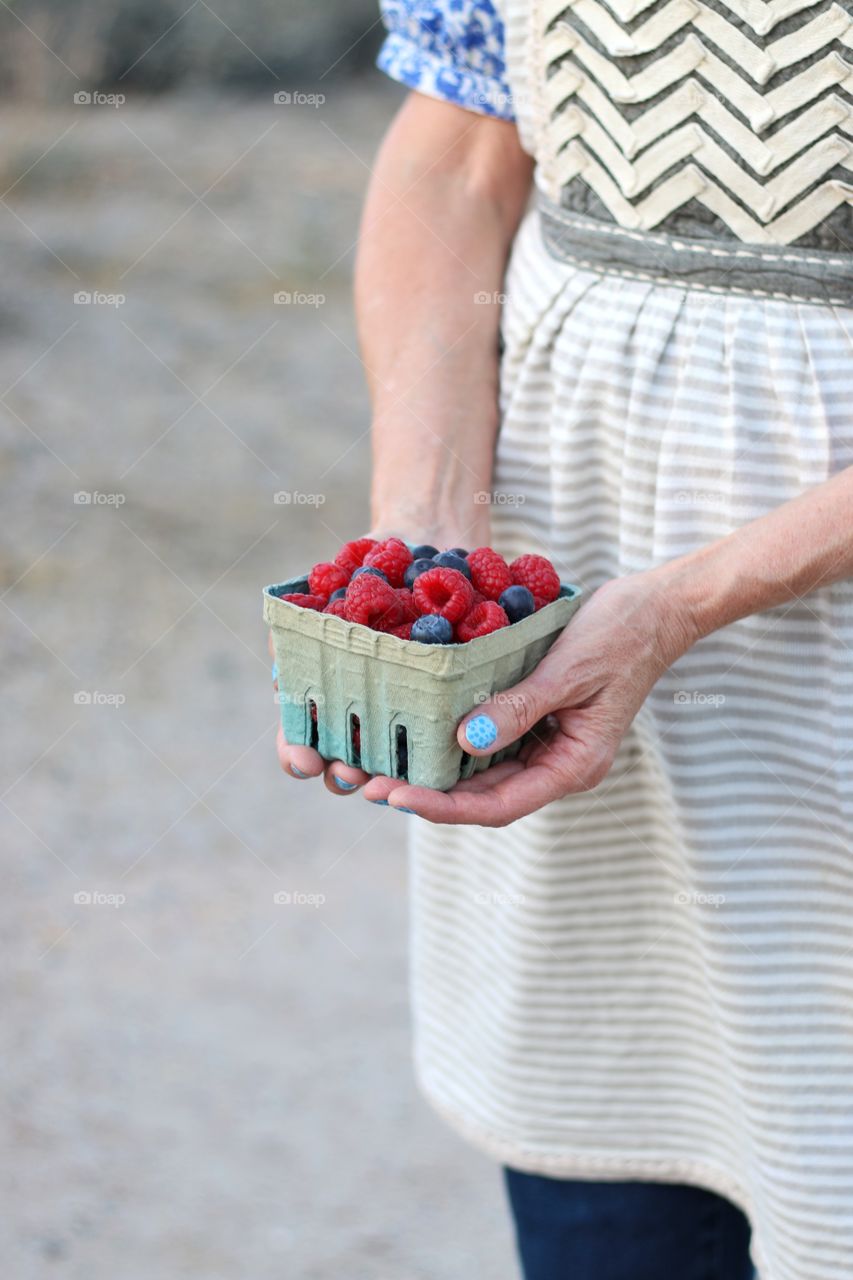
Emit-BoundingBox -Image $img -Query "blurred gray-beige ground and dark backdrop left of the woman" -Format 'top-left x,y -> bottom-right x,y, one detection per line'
0,0 -> 515,1280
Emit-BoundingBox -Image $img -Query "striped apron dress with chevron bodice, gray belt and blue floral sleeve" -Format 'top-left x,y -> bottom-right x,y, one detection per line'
382,0 -> 853,1280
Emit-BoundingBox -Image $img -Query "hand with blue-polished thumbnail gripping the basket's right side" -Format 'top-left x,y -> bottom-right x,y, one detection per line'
364,571 -> 694,827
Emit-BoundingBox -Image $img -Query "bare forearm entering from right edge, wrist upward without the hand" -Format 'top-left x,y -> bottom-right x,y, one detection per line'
652,468 -> 853,639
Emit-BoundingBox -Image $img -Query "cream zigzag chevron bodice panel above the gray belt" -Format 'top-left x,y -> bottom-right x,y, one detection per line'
530,0 -> 853,251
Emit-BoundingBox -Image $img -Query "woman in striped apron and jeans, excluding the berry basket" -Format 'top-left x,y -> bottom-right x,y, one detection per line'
279,0 -> 853,1280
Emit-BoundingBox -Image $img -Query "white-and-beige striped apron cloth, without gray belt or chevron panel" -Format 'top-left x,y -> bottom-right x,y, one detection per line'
402,0 -> 853,1280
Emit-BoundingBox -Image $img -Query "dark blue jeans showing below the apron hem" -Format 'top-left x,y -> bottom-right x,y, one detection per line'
505,1169 -> 754,1280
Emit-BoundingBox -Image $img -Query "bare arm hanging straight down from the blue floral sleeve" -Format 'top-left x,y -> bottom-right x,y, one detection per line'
356,93 -> 530,538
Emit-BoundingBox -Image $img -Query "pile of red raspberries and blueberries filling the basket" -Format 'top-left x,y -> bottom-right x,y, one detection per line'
275,538 -> 560,644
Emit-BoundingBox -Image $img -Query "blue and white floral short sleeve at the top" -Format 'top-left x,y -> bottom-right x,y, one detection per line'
377,0 -> 515,120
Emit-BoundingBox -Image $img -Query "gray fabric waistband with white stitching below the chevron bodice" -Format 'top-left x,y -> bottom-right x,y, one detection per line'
538,196 -> 853,307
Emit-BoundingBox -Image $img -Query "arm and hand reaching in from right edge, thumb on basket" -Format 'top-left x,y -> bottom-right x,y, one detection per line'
365,468 -> 853,827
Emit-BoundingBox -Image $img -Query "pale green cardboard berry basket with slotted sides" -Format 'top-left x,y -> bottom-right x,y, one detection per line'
264,577 -> 583,791
